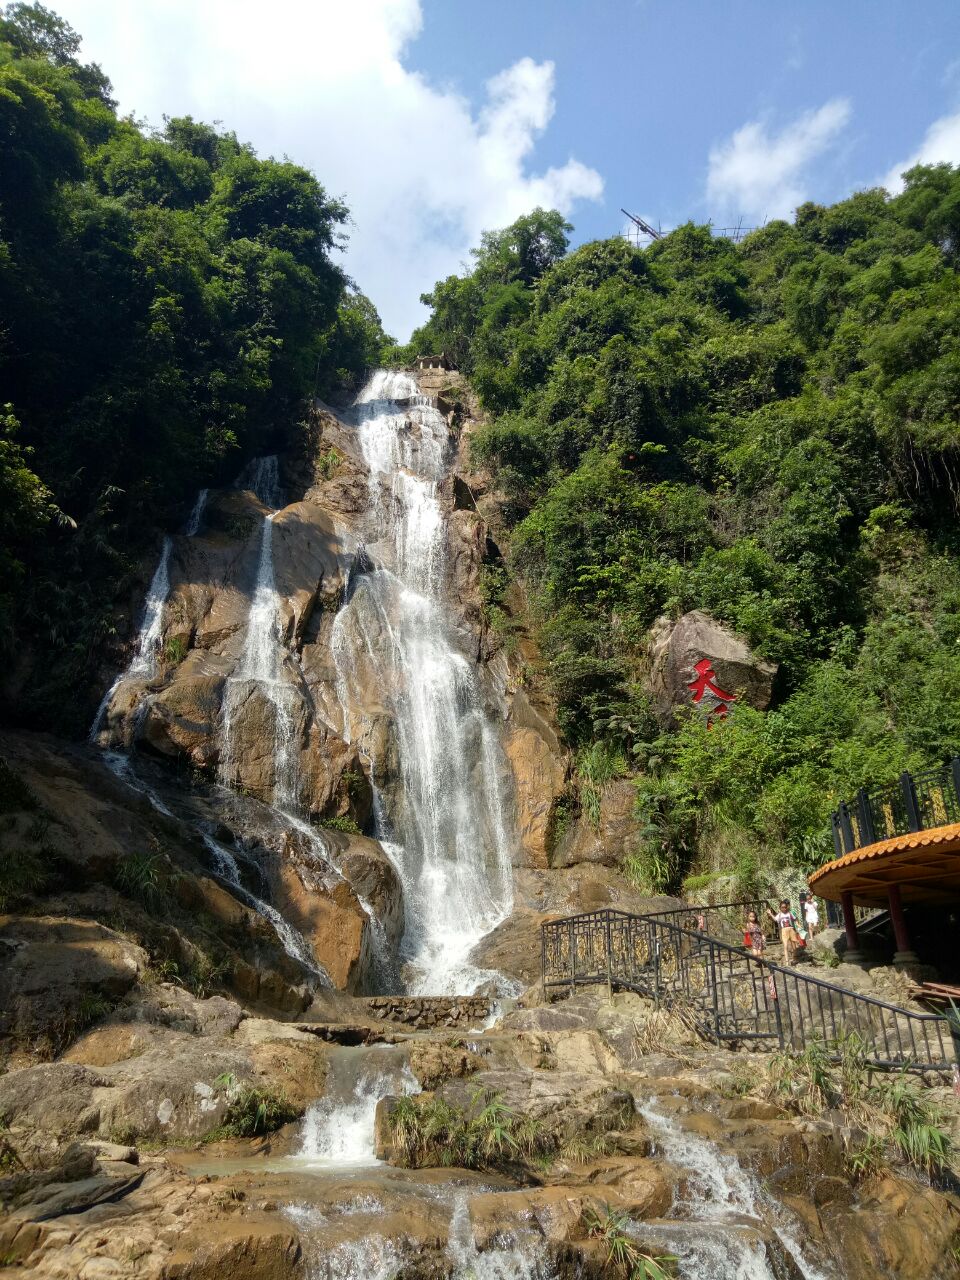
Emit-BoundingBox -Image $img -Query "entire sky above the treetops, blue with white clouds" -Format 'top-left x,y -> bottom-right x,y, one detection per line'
60,0 -> 960,338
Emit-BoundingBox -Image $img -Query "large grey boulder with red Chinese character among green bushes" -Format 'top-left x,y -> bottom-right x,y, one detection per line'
646,609 -> 777,724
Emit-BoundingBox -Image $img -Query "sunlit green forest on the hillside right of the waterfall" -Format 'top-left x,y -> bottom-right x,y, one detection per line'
399,165 -> 960,888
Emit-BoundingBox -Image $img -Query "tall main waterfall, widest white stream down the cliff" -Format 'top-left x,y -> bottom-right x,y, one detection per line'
332,370 -> 512,995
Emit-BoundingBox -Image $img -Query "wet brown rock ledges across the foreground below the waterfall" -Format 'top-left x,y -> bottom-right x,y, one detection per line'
0,988 -> 960,1280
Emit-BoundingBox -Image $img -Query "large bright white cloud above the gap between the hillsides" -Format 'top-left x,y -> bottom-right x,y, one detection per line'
55,0 -> 603,338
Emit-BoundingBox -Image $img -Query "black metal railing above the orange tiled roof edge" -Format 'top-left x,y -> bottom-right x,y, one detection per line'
831,755 -> 960,858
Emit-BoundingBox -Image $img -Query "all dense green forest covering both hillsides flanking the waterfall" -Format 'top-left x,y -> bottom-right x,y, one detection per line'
0,4 -> 960,888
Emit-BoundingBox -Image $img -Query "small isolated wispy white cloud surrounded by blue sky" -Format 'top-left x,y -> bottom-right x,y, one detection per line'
707,99 -> 850,220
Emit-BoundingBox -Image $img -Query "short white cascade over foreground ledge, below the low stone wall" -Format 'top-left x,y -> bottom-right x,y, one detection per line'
298,1046 -> 420,1167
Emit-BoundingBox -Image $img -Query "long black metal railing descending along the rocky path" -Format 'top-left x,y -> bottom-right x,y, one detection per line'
540,904 -> 957,1071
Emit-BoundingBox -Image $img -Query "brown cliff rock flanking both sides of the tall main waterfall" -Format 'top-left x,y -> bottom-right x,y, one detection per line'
88,370 -> 568,989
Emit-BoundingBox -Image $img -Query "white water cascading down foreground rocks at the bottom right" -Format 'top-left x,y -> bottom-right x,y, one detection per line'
637,1100 -> 829,1280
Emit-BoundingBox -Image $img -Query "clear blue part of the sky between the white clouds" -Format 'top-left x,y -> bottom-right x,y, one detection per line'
419,0 -> 960,239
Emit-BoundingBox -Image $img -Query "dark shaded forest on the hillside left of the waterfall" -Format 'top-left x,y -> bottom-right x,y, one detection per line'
0,4 -> 383,732
